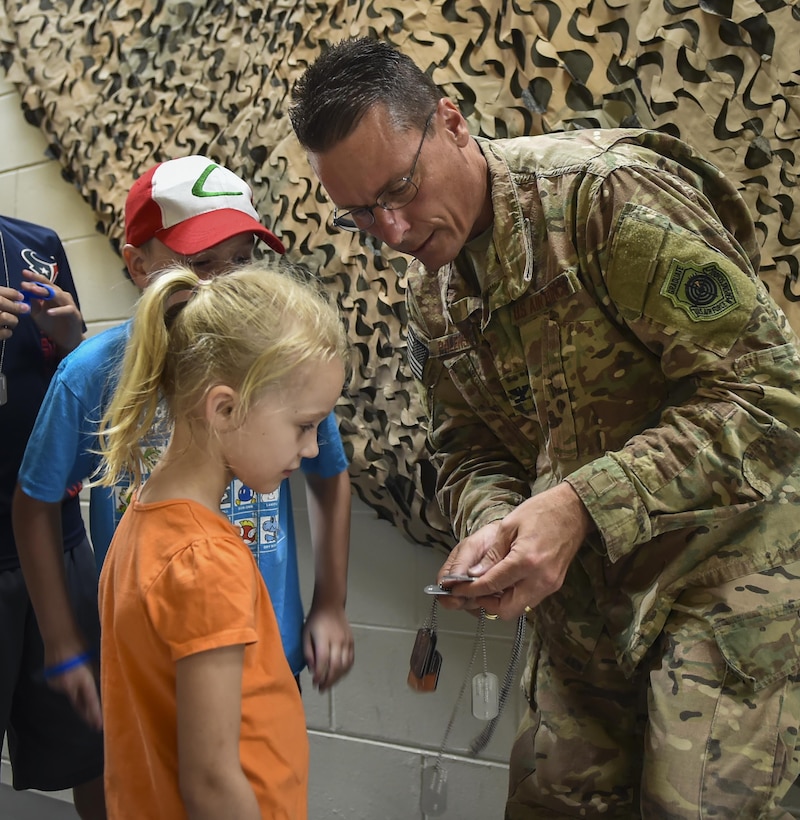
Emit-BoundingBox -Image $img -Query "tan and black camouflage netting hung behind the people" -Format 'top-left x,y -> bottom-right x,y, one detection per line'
0,0 -> 800,548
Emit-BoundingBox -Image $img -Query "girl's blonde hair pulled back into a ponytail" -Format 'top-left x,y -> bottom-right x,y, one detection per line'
96,261 -> 349,485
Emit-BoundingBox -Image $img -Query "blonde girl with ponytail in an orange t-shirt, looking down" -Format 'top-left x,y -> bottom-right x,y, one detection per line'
94,263 -> 346,820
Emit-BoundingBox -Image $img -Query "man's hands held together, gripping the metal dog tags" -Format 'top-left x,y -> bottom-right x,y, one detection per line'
439,482 -> 594,619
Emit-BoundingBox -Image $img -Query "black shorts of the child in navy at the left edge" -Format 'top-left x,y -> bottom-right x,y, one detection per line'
0,540 -> 103,791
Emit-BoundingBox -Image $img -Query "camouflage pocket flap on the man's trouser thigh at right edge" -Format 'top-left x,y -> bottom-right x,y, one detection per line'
714,601 -> 800,691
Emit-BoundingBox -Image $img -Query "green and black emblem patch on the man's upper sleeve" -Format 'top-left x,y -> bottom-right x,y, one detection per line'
661,259 -> 739,322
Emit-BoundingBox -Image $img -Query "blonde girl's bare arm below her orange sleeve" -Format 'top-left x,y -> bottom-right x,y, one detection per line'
175,644 -> 261,820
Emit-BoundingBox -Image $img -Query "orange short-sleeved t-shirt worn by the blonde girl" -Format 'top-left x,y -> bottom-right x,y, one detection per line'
100,499 -> 308,820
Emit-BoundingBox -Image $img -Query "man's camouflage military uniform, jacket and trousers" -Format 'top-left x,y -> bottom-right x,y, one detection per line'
408,130 -> 800,820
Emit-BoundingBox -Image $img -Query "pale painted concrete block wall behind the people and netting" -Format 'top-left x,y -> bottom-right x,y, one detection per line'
0,67 -> 523,820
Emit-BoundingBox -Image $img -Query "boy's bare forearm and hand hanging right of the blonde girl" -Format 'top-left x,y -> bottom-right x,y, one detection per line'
303,470 -> 354,691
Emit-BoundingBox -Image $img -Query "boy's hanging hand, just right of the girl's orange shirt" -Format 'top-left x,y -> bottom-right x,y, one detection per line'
303,604 -> 355,692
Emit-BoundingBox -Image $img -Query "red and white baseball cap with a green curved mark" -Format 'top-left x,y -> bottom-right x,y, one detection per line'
125,155 -> 286,256
